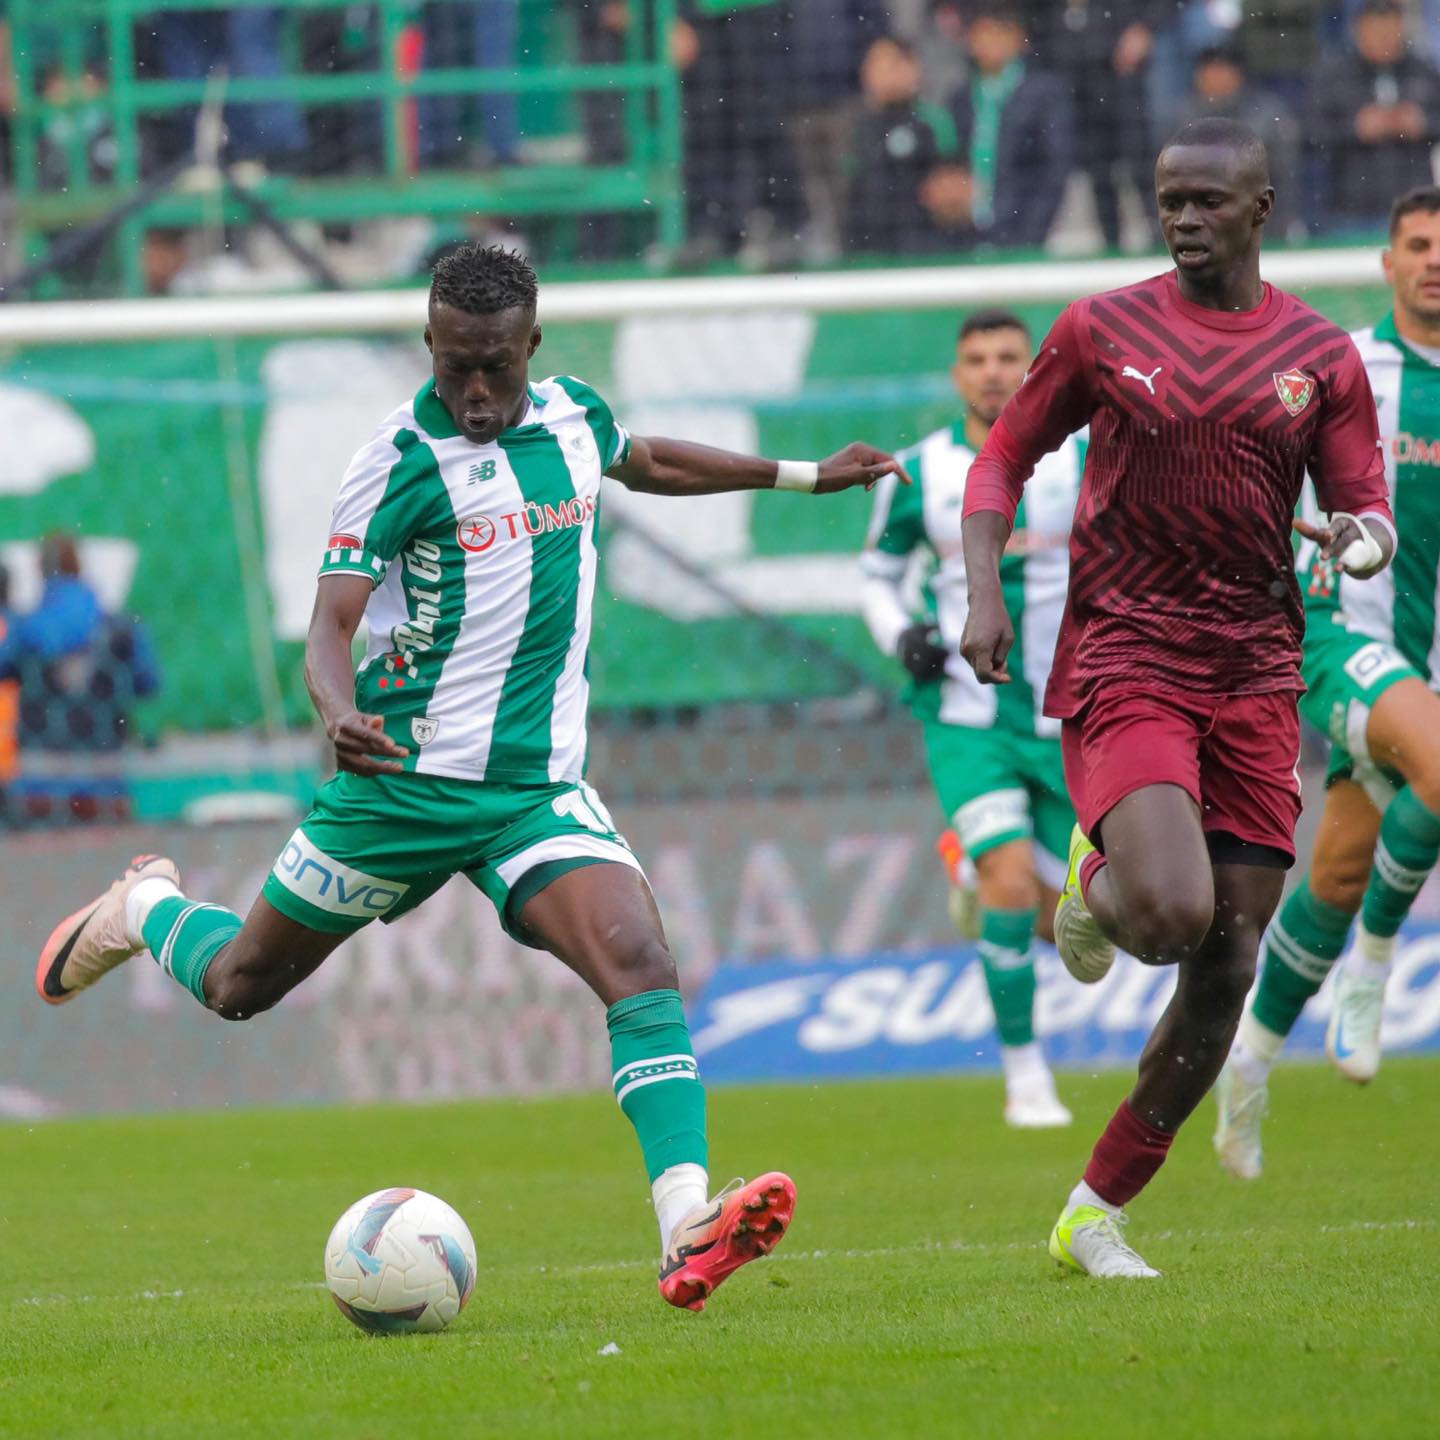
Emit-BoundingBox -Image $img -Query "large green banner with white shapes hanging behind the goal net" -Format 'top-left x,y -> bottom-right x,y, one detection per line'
0,289 -> 1385,733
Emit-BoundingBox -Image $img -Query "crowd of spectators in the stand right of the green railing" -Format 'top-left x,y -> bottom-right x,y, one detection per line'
678,0 -> 1440,258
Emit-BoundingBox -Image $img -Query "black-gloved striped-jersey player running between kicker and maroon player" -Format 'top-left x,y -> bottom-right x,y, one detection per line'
861,310 -> 1084,1128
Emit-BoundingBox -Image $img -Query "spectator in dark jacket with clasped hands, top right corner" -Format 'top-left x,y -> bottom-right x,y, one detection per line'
1306,0 -> 1440,230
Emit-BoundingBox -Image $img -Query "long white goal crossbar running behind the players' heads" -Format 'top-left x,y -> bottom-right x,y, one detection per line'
0,246 -> 1381,346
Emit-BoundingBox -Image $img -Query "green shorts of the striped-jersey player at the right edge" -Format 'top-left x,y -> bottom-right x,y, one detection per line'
1300,612 -> 1424,802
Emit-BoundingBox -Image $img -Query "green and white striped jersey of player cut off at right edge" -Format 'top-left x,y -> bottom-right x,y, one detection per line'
1299,314 -> 1440,685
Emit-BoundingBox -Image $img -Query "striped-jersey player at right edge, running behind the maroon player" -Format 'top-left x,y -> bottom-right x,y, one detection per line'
1215,186 -> 1440,1179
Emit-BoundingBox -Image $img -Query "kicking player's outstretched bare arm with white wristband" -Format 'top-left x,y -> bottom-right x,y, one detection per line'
606,435 -> 910,495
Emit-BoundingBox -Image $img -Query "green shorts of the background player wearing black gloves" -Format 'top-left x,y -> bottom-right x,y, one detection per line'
924,720 -> 1076,886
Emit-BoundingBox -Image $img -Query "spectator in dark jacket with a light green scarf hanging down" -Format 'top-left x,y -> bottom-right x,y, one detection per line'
932,3 -> 1074,246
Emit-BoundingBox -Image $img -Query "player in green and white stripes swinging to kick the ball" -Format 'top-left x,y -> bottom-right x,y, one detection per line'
36,245 -> 899,1310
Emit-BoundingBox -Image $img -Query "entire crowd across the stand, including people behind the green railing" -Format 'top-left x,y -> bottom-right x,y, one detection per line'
8,0 -> 1440,262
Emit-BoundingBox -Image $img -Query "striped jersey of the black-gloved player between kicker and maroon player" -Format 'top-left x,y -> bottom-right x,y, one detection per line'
861,422 -> 1087,736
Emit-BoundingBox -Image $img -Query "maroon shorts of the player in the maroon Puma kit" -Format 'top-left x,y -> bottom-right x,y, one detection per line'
1061,688 -> 1300,860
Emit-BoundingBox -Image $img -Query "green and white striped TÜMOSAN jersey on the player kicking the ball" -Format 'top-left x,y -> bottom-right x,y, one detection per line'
320,376 -> 629,783
